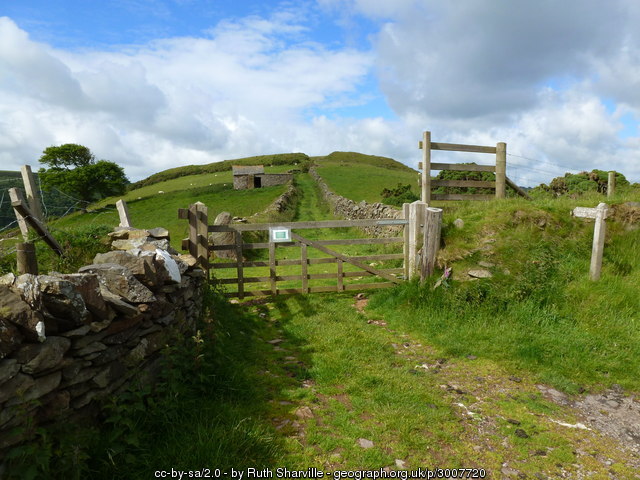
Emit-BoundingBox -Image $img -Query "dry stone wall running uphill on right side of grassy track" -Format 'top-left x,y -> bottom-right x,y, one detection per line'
309,167 -> 403,235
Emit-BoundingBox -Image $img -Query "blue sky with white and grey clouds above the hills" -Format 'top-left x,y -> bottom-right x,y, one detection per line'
0,0 -> 640,186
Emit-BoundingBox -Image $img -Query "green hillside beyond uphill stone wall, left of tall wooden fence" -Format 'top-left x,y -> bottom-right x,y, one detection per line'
312,152 -> 420,203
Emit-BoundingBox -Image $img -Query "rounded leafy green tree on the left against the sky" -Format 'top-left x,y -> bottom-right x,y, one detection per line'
38,143 -> 129,209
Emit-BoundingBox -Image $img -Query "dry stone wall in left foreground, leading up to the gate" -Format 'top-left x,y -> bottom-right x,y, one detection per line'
0,228 -> 205,456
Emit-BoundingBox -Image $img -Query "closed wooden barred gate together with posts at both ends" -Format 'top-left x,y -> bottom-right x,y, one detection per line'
178,202 -> 442,298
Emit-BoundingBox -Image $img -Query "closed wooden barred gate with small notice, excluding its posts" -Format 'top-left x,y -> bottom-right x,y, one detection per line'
209,219 -> 408,298
